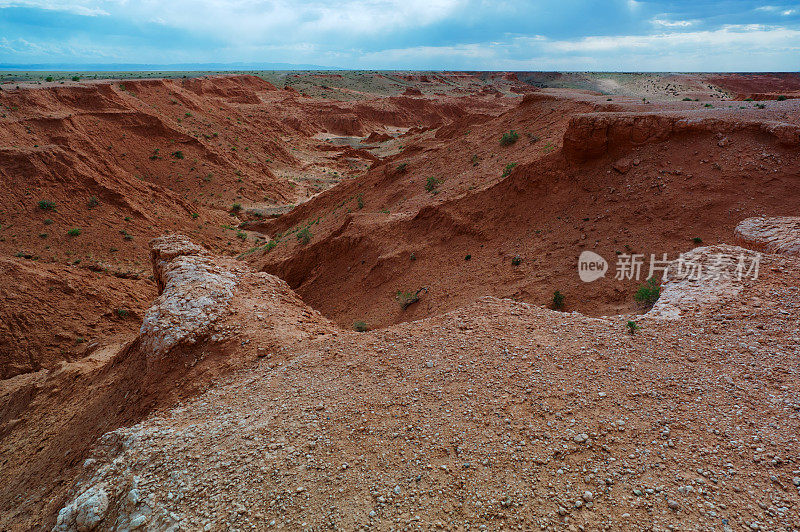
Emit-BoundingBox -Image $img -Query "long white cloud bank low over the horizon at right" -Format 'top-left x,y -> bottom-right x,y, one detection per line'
358,25 -> 800,71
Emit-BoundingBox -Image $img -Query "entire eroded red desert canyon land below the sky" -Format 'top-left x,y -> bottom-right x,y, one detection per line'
0,72 -> 800,531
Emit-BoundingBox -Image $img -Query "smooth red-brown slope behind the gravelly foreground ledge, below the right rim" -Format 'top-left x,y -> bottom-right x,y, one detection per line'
245,93 -> 800,327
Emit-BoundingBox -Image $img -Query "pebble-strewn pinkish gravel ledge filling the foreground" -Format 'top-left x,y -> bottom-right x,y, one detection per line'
34,233 -> 800,530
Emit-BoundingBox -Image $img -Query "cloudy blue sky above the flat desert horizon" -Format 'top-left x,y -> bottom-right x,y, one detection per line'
0,0 -> 800,72
